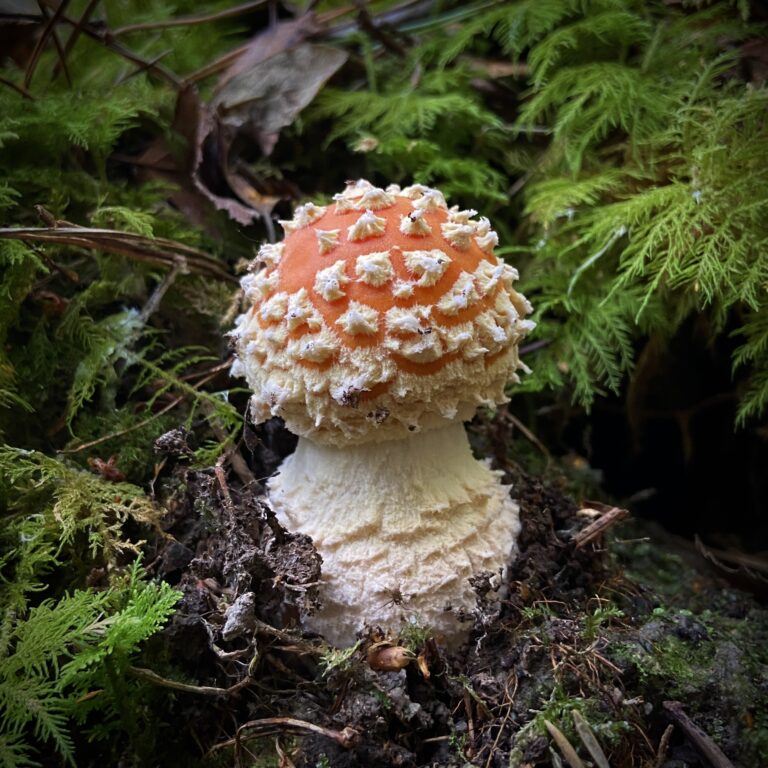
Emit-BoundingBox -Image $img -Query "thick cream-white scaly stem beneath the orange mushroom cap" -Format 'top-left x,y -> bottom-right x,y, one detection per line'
269,422 -> 520,646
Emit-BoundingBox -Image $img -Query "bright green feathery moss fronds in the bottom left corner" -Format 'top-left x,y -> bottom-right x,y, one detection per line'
0,562 -> 180,765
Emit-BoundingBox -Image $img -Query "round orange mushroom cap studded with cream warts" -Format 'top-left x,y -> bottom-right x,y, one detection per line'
233,180 -> 533,443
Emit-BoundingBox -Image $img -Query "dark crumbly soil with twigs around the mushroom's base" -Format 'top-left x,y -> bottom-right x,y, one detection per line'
142,422 -> 768,768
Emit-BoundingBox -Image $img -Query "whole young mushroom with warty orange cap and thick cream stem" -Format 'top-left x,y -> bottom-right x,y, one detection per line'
232,180 -> 533,645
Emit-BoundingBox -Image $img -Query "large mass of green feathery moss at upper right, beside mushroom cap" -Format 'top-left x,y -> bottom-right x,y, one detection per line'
314,0 -> 768,424
